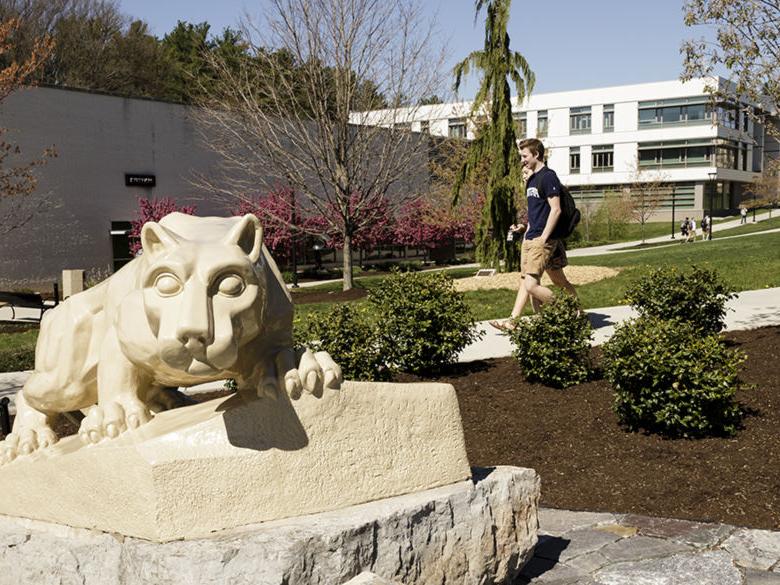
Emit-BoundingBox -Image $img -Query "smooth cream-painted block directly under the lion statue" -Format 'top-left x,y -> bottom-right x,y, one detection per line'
0,382 -> 470,542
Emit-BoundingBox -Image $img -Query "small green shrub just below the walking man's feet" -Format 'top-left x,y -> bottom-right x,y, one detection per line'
509,294 -> 592,388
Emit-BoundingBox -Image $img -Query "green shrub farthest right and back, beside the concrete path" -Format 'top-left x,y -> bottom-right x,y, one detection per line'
626,266 -> 736,334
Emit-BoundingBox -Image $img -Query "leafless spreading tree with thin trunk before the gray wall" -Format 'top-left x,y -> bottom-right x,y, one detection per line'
194,0 -> 443,289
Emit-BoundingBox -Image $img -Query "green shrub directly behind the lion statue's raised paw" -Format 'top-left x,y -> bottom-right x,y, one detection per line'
296,303 -> 390,380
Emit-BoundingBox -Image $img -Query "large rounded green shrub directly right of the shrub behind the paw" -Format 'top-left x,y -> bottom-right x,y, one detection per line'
368,270 -> 481,373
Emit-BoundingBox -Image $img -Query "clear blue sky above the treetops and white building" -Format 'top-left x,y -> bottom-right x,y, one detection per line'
119,0 -> 704,98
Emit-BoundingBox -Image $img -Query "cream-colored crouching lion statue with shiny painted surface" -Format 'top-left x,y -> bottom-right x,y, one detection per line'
0,213 -> 341,463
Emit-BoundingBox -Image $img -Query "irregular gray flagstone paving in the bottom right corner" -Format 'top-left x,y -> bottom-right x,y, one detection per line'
516,508 -> 780,585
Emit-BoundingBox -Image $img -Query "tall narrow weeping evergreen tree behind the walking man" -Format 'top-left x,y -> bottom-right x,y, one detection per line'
453,0 -> 535,271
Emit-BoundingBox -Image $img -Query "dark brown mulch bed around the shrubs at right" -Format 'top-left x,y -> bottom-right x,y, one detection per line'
398,327 -> 780,530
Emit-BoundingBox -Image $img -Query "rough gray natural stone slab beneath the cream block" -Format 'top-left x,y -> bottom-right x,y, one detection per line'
0,467 -> 539,585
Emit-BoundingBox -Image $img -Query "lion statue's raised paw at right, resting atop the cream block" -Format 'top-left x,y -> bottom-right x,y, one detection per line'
266,349 -> 342,400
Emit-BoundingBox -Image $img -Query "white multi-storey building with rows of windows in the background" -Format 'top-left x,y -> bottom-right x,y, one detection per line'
353,78 -> 778,219
